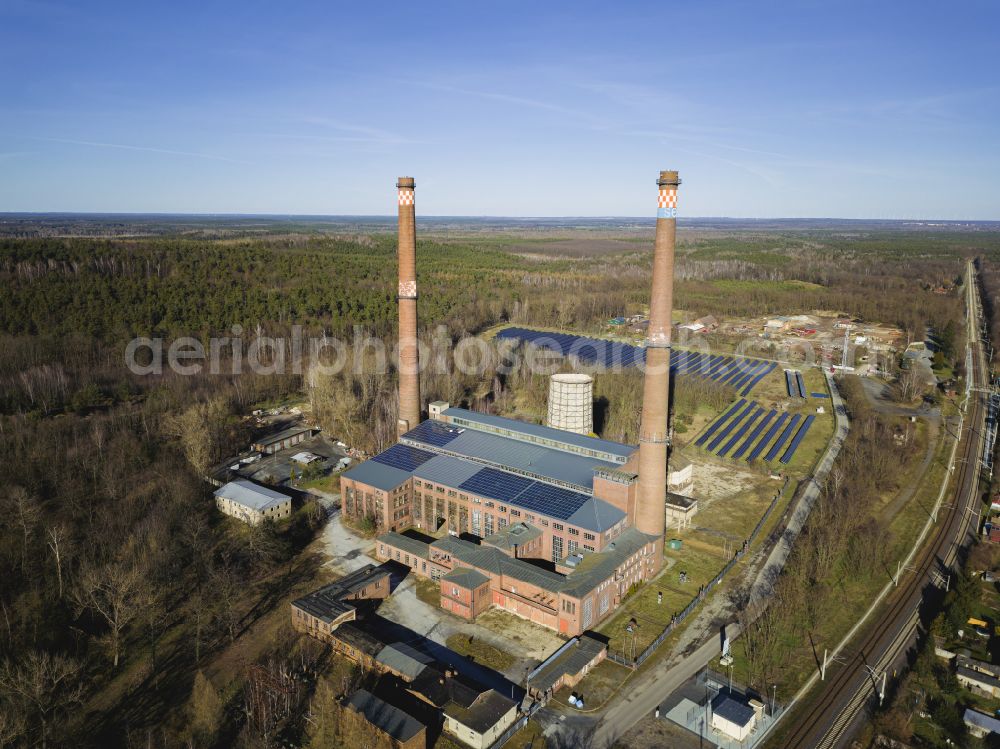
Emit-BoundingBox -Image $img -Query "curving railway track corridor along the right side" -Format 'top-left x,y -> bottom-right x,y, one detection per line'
780,274 -> 986,749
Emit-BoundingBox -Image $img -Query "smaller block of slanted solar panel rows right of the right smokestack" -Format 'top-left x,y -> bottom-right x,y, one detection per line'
694,400 -> 816,463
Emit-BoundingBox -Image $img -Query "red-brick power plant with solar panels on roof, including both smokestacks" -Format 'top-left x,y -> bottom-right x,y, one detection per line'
341,172 -> 680,635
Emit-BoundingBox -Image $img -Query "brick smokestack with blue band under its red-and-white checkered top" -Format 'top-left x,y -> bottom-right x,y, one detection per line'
635,172 -> 681,566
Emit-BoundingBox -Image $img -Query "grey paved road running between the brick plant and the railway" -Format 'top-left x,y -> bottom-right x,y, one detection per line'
566,373 -> 848,747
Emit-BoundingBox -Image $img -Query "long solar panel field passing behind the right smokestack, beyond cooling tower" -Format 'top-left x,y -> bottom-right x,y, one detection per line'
496,328 -> 777,396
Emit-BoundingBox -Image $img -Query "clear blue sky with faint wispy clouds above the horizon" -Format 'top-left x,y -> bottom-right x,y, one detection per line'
0,0 -> 1000,219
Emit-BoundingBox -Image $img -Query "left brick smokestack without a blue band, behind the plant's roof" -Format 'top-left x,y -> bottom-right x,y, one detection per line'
396,177 -> 420,435
